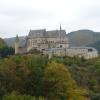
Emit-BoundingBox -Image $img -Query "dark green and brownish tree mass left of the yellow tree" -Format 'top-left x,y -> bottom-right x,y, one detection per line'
0,55 -> 47,96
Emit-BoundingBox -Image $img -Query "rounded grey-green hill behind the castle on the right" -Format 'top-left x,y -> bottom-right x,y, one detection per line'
67,30 -> 100,46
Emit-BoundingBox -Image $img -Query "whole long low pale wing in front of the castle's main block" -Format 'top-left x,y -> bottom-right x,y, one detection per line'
43,47 -> 98,59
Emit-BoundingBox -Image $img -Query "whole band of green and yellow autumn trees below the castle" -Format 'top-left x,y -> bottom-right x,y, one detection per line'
0,55 -> 100,100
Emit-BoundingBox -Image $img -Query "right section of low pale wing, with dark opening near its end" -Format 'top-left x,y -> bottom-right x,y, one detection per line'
66,47 -> 98,59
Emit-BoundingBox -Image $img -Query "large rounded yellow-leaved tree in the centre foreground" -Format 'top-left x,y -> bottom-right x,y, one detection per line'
44,62 -> 85,100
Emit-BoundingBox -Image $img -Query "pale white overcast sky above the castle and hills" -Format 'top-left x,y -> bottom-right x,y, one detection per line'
0,0 -> 100,38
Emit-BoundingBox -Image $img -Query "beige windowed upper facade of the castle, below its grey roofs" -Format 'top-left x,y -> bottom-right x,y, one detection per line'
28,37 -> 68,50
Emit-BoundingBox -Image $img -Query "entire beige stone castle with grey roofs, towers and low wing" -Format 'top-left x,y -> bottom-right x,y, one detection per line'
15,26 -> 98,59
